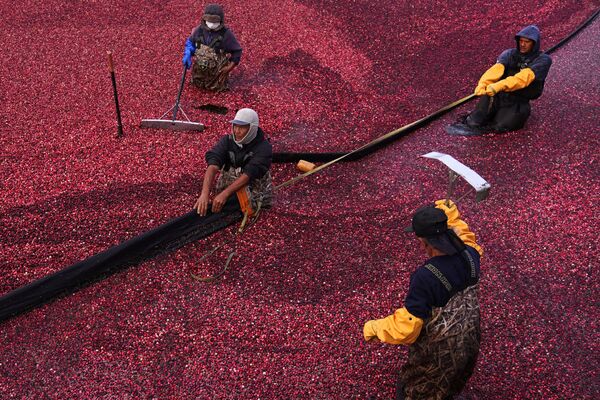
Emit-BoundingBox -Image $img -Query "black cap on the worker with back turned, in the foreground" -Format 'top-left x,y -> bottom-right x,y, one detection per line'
404,206 -> 464,255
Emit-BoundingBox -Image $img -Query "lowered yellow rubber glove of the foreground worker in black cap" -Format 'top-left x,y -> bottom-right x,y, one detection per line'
363,307 -> 423,345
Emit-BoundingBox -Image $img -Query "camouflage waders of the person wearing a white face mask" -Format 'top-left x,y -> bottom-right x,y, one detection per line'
192,36 -> 229,92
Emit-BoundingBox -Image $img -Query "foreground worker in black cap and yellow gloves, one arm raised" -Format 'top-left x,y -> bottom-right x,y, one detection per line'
363,200 -> 483,400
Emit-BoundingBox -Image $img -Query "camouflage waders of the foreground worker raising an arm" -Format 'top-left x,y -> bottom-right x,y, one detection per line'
399,285 -> 481,400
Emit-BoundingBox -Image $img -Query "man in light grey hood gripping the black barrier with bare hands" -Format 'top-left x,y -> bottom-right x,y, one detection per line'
194,108 -> 273,216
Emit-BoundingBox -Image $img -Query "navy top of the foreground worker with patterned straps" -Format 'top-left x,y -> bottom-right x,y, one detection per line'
404,246 -> 480,319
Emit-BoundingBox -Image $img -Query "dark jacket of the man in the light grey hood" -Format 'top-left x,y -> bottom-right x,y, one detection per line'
206,128 -> 273,182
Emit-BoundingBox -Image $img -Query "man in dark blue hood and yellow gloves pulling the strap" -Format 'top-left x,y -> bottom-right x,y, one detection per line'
459,25 -> 552,135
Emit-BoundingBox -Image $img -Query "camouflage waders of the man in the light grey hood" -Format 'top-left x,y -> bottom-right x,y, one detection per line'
215,166 -> 273,216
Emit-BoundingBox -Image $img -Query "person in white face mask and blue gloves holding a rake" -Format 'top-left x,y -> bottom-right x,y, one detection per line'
182,4 -> 242,92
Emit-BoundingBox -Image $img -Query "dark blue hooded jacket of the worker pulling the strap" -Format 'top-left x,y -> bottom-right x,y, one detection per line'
497,25 -> 552,101
